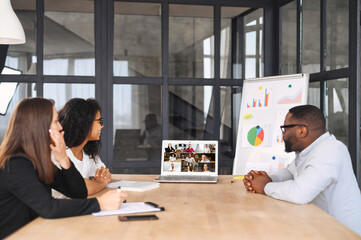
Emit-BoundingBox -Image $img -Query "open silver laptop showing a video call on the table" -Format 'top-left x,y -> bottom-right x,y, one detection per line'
155,140 -> 218,183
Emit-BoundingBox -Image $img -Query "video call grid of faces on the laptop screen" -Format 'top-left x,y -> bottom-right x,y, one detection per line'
162,140 -> 218,175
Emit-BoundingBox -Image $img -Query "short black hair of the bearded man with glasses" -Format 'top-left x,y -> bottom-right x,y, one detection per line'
289,105 -> 326,132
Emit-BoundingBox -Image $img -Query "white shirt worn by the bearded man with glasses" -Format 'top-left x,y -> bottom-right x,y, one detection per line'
264,132 -> 361,236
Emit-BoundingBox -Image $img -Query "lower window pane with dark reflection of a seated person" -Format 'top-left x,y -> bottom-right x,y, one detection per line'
113,84 -> 163,165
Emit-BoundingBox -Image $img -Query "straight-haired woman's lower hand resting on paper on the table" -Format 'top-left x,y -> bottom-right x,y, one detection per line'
97,189 -> 128,210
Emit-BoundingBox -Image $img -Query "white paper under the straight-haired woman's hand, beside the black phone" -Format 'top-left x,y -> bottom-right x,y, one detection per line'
93,202 -> 162,217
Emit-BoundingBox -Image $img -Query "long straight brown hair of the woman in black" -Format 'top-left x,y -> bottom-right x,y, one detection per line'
0,98 -> 56,184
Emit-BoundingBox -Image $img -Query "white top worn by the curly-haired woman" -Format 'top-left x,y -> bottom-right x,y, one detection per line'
51,148 -> 106,178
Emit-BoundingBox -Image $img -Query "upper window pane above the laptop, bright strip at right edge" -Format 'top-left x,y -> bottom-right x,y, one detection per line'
169,4 -> 214,78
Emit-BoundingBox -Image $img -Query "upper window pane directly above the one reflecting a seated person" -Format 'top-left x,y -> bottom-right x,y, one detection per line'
113,2 -> 162,77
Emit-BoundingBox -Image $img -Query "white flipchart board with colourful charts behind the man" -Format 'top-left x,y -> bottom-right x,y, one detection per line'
233,74 -> 309,175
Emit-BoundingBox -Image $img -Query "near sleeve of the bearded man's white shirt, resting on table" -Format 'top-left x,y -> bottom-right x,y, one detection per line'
265,156 -> 337,204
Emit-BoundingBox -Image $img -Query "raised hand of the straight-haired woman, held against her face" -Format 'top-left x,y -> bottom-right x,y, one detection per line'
49,129 -> 71,169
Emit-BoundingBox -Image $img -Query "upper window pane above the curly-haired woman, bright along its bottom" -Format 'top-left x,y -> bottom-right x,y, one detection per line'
44,0 -> 95,76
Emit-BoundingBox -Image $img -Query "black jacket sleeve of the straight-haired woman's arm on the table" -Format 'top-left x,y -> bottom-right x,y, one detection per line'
7,157 -> 100,218
